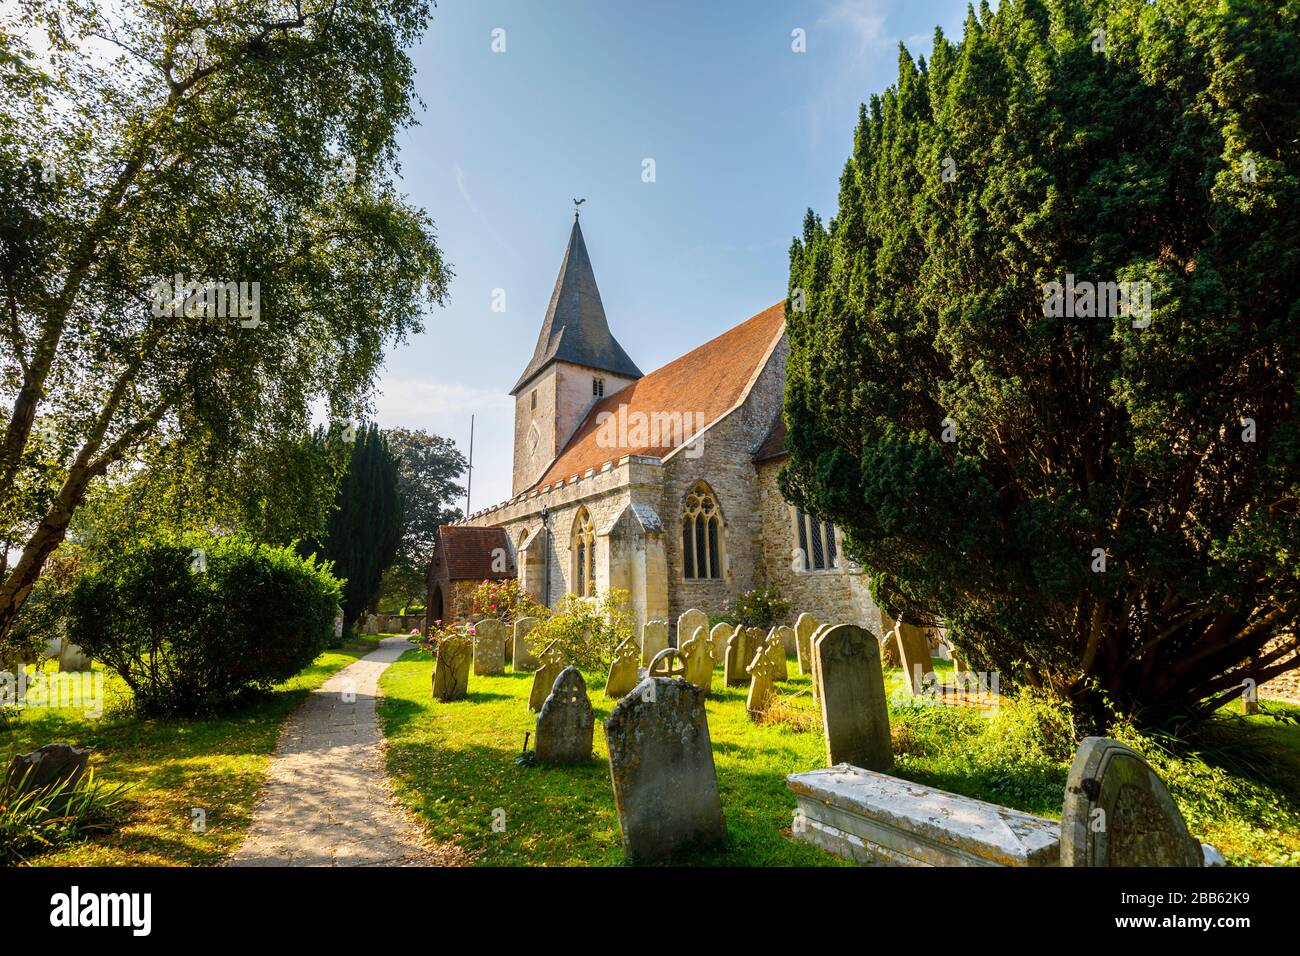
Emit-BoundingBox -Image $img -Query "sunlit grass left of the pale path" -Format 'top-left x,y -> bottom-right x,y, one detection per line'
0,636 -> 378,866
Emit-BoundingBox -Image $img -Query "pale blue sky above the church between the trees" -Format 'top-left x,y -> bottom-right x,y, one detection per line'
376,0 -> 966,510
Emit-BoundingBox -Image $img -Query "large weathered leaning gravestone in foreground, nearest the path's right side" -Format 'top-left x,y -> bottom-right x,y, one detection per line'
605,678 -> 727,862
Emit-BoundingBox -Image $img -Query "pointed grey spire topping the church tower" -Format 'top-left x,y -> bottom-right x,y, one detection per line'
510,215 -> 642,395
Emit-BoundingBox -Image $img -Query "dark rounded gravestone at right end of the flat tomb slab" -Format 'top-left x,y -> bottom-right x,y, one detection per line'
1061,737 -> 1204,866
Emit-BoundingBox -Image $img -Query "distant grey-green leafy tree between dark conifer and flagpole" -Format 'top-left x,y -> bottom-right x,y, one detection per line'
380,428 -> 465,606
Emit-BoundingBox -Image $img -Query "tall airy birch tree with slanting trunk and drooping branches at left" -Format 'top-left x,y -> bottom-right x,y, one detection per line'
0,0 -> 450,657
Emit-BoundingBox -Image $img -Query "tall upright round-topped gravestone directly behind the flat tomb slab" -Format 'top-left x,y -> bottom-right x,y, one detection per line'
813,624 -> 893,770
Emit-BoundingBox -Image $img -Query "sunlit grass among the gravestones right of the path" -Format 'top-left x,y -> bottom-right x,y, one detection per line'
378,650 -> 1300,866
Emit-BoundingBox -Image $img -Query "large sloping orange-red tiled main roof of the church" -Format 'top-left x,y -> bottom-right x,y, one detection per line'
533,302 -> 785,488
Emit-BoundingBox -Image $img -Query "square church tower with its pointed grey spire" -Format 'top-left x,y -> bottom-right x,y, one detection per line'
510,212 -> 641,494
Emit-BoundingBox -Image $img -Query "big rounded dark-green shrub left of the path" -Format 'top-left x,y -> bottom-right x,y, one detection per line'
69,536 -> 342,714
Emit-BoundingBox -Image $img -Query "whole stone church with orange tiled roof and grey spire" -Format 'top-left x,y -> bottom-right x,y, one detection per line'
429,219 -> 881,633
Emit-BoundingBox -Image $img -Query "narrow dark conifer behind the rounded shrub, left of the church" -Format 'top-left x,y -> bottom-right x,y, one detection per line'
302,425 -> 403,624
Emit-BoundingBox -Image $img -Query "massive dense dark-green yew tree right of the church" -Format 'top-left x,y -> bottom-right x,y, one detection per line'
781,0 -> 1300,724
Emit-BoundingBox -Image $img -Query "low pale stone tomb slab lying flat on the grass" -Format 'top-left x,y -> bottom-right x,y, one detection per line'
785,763 -> 1061,866
